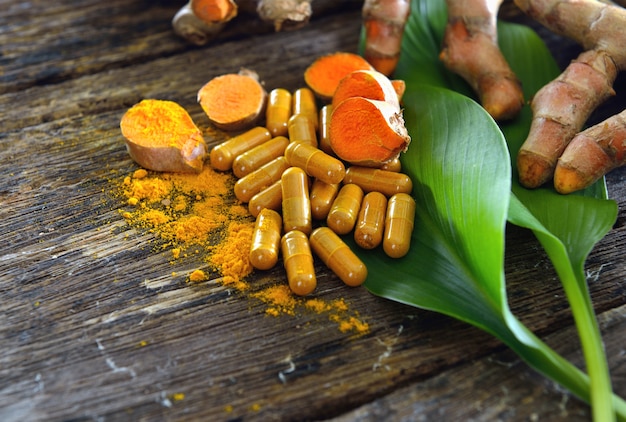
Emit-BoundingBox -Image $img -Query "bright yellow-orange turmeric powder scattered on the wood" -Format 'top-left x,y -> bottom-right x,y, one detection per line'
111,166 -> 369,335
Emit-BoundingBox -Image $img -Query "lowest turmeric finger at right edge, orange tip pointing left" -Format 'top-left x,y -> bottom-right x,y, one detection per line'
554,111 -> 626,194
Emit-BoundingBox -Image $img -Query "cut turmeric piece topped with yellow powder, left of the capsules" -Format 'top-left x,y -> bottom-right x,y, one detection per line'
120,99 -> 207,172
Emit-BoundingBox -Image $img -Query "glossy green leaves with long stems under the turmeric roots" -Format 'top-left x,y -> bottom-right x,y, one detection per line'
356,0 -> 626,419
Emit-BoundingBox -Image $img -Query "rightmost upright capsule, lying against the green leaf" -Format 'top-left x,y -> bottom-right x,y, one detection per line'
383,193 -> 415,258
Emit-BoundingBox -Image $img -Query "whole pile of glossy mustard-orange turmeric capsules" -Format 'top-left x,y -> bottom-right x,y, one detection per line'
210,83 -> 415,296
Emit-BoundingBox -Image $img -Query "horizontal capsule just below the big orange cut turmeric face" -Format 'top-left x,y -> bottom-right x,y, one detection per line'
343,166 -> 413,197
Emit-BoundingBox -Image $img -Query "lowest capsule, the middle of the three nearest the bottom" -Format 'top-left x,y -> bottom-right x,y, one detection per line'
280,230 -> 317,296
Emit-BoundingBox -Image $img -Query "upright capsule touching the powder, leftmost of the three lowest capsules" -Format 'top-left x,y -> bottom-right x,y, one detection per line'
249,208 -> 283,270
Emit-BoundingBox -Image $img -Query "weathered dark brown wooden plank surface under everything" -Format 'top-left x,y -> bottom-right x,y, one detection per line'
0,0 -> 626,421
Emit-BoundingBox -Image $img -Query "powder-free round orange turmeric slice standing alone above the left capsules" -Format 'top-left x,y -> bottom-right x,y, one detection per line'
198,69 -> 267,131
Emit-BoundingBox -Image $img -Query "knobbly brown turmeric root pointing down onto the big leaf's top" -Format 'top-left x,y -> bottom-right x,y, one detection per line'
439,0 -> 524,120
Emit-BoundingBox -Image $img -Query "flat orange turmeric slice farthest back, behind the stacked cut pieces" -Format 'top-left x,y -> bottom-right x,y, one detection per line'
304,52 -> 373,100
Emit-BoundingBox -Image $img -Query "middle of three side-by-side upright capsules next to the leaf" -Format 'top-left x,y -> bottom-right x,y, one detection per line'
354,192 -> 387,249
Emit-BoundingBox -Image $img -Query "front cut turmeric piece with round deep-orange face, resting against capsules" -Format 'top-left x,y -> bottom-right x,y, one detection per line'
329,97 -> 411,167
